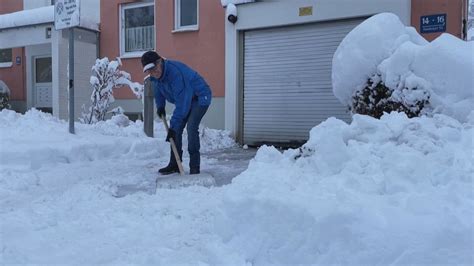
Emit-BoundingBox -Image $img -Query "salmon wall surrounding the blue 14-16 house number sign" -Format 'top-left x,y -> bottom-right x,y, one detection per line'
411,0 -> 467,41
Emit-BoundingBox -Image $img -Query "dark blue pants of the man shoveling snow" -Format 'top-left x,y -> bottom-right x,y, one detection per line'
170,99 -> 209,169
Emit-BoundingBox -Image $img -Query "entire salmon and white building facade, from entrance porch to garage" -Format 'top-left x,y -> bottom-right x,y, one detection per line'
0,0 -> 467,145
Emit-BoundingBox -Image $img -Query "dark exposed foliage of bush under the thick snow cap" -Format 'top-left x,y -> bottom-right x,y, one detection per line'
350,75 -> 430,118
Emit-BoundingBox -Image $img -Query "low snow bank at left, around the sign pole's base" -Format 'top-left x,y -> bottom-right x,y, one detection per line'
0,109 -> 156,169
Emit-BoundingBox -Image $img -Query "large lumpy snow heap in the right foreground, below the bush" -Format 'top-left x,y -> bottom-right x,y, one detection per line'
224,113 -> 474,265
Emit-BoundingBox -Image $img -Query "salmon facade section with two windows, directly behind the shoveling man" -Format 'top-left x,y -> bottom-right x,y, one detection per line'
100,0 -> 225,128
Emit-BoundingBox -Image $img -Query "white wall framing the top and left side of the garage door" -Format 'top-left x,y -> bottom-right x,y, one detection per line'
225,0 -> 411,136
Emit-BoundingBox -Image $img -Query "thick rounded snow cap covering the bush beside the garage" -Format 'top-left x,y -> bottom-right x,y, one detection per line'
332,13 -> 474,121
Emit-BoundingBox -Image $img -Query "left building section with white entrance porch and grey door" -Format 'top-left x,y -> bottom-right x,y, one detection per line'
0,0 -> 99,119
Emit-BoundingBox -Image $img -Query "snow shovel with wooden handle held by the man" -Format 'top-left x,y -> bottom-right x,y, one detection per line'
156,117 -> 216,189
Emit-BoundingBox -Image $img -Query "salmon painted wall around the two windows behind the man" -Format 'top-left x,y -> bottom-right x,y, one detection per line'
100,0 -> 225,99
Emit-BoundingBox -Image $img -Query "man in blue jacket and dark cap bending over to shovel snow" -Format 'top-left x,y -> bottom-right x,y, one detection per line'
141,51 -> 212,175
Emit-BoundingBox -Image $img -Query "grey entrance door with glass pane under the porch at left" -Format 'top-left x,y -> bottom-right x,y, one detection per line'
33,56 -> 53,111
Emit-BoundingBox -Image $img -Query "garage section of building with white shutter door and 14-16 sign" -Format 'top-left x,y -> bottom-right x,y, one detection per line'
225,0 -> 467,146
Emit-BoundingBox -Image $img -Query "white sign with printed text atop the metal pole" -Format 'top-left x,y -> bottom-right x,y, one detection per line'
54,0 -> 80,30
